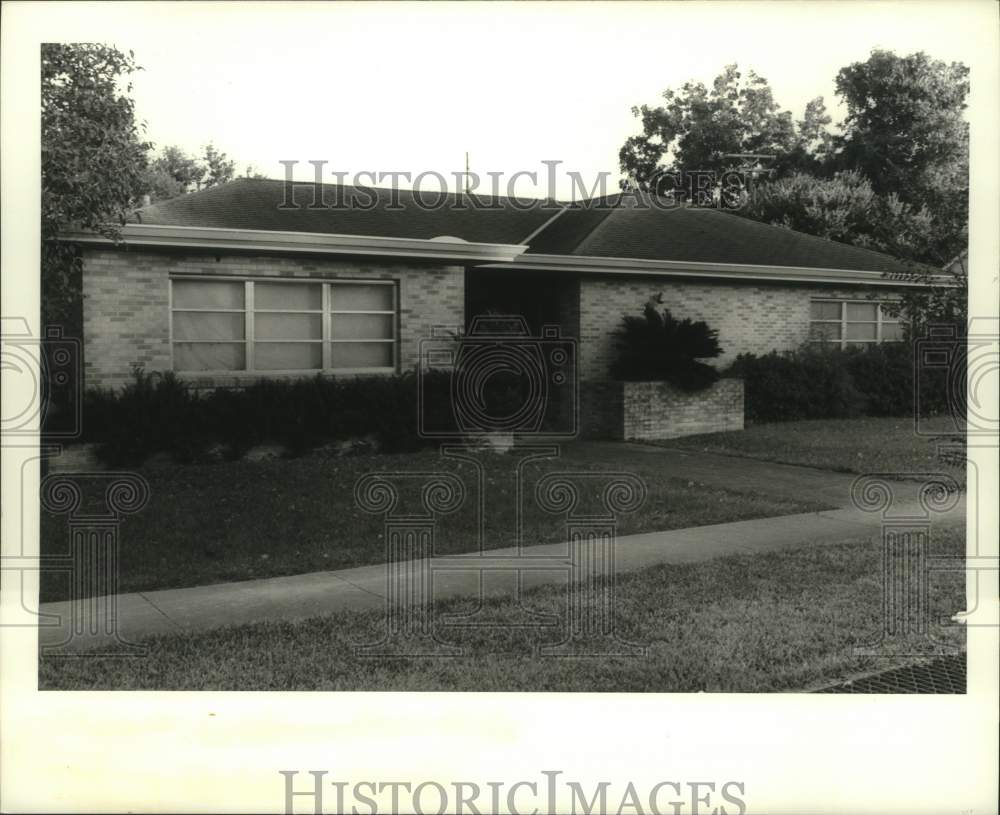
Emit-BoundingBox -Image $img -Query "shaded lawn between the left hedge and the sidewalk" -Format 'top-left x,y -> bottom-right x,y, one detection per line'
41,448 -> 829,601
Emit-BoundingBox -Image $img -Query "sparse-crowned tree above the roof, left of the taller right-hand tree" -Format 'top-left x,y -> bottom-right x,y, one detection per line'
618,65 -> 830,194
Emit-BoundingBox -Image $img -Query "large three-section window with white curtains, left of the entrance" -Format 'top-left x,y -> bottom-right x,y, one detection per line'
171,279 -> 397,374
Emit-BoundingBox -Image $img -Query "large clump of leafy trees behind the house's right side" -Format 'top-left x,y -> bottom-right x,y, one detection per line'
619,50 -> 969,332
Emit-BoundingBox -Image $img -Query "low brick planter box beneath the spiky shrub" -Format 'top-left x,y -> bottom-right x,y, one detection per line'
580,379 -> 743,440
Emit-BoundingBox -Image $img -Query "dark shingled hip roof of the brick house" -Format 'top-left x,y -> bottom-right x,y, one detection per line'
136,179 -> 912,273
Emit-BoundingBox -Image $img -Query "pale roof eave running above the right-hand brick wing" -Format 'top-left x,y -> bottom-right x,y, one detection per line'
478,254 -> 953,288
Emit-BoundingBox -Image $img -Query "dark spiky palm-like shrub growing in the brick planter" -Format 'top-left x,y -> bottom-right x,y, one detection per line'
611,295 -> 722,391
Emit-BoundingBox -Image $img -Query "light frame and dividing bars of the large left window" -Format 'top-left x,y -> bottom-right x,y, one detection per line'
168,275 -> 399,378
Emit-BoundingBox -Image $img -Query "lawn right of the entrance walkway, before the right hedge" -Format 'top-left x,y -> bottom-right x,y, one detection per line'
660,417 -> 965,484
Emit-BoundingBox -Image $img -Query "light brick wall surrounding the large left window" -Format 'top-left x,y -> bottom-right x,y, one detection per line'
83,248 -> 465,387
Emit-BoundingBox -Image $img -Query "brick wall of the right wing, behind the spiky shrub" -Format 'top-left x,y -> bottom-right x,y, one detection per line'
579,277 -> 884,381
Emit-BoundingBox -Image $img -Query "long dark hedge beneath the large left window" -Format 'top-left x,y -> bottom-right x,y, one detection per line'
83,369 -> 453,465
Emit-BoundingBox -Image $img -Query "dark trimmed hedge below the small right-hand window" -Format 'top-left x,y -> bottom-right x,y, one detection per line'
726,343 -> 948,422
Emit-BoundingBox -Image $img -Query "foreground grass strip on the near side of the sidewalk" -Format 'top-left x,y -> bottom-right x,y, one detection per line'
39,530 -> 965,692
